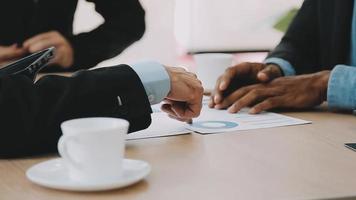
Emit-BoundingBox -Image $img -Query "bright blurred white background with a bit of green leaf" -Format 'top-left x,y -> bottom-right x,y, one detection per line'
74,0 -> 302,67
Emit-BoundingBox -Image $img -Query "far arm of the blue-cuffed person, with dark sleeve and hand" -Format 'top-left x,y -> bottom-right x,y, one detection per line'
209,0 -> 319,108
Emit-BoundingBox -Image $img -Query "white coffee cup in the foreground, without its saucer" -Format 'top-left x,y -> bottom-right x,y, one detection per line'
58,117 -> 129,181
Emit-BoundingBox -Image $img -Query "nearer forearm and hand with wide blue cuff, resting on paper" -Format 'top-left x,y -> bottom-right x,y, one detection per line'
209,65 -> 356,114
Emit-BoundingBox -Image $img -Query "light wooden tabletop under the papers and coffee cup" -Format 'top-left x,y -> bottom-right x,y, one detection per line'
0,109 -> 356,200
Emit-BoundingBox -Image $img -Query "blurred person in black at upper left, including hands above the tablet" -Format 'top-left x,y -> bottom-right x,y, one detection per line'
0,0 -> 145,71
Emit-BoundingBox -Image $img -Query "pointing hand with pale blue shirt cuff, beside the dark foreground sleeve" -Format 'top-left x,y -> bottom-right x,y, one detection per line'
132,62 -> 203,123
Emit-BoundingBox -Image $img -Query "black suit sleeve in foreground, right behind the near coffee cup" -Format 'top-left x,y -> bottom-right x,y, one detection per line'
0,65 -> 152,158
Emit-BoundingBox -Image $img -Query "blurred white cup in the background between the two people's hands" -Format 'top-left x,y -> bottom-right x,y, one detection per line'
194,53 -> 233,92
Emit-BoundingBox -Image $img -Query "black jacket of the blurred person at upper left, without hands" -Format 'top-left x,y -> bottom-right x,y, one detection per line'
0,0 -> 145,71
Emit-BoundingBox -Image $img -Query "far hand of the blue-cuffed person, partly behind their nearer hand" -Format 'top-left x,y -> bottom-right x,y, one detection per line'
209,63 -> 282,108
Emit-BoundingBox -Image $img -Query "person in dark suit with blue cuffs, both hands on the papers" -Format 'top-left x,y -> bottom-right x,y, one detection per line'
209,0 -> 356,113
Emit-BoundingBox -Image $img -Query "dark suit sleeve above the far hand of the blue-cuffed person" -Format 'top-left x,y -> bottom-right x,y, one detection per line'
268,0 -> 319,74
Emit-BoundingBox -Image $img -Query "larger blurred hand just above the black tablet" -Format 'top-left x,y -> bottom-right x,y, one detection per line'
23,31 -> 74,68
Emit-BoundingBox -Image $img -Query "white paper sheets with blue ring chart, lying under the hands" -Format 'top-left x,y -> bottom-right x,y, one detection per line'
127,99 -> 311,139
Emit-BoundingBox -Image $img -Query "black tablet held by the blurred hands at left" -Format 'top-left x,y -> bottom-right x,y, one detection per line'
0,47 -> 54,80
